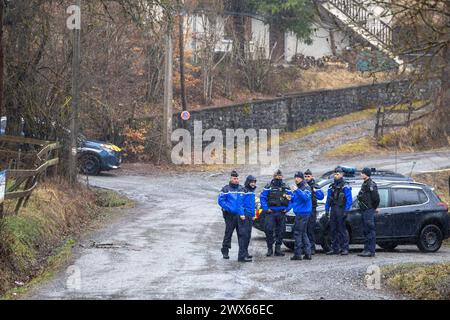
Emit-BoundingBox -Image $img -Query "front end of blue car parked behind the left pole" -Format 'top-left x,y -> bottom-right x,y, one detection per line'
78,136 -> 122,175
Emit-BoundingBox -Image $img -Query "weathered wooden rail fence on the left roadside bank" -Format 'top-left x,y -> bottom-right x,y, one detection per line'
0,135 -> 61,216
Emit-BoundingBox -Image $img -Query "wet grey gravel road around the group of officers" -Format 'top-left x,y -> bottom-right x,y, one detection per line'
27,119 -> 450,299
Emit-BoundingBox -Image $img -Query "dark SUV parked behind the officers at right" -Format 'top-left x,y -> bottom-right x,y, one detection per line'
284,180 -> 450,252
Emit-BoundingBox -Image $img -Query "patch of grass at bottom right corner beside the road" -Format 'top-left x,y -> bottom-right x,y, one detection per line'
382,262 -> 450,300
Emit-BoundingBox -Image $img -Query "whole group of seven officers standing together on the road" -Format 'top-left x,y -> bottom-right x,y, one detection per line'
218,167 -> 380,262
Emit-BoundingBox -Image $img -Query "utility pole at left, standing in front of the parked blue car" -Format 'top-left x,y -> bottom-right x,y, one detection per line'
69,0 -> 81,185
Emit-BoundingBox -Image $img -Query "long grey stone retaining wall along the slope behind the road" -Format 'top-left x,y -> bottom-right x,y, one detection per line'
173,81 -> 438,132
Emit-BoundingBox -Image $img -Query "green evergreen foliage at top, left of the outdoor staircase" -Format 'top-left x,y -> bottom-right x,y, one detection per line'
251,0 -> 316,44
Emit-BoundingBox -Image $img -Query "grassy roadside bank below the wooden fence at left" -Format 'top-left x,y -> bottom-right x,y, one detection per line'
0,181 -> 132,298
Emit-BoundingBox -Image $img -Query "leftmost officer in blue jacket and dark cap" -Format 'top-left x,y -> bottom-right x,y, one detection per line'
218,170 -> 244,259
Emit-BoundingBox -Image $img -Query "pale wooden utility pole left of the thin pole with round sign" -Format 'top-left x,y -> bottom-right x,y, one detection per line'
162,22 -> 173,159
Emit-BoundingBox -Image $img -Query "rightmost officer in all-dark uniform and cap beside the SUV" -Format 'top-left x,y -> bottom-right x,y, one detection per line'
358,168 -> 380,257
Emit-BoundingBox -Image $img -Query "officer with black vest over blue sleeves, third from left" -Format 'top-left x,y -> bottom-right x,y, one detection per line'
260,170 -> 292,257
